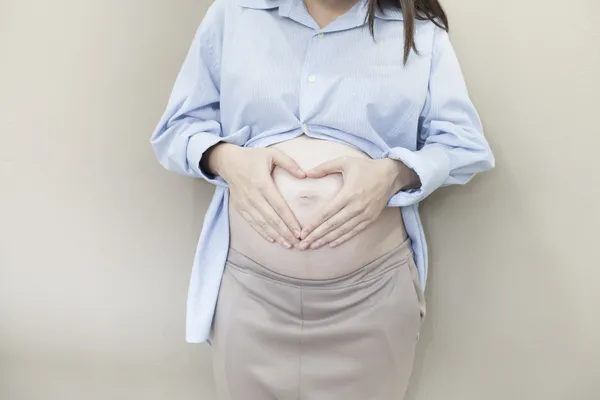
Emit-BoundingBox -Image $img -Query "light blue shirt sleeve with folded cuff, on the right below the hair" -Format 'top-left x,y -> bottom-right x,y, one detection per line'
386,28 -> 495,207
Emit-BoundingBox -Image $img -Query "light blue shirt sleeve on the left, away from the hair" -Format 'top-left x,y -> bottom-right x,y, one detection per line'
150,2 -> 232,185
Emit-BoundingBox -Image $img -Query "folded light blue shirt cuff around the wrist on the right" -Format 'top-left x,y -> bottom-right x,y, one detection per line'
385,144 -> 450,207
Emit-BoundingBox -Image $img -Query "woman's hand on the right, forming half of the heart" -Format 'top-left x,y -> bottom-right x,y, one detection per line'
299,157 -> 420,250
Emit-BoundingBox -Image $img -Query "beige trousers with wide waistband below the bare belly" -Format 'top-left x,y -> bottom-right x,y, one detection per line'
211,241 -> 425,400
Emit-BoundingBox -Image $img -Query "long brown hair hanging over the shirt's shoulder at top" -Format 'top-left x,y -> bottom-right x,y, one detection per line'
366,0 -> 449,64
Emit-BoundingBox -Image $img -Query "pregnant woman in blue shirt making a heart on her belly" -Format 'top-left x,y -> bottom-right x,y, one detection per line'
151,0 -> 494,400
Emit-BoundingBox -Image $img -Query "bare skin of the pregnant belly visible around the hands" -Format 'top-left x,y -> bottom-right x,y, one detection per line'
229,135 -> 407,279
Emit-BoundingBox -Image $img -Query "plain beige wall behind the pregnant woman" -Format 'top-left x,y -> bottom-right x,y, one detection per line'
0,0 -> 600,400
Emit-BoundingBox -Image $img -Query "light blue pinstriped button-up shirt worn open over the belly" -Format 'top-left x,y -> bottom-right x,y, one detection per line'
151,0 -> 494,342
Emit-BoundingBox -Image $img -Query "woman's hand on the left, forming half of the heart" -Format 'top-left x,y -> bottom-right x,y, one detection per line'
206,143 -> 306,249
